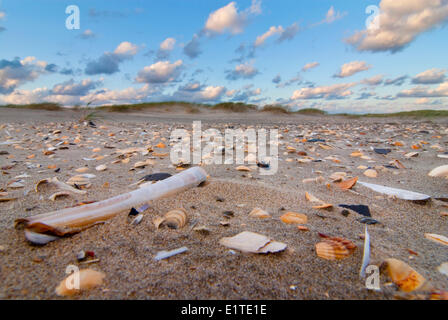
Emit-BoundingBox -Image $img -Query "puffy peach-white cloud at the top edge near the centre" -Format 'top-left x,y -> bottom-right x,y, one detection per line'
204,0 -> 261,35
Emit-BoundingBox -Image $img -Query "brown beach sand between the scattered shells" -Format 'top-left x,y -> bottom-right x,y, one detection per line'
0,109 -> 448,300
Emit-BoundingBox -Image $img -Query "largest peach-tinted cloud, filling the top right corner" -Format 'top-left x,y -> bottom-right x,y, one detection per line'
346,0 -> 448,52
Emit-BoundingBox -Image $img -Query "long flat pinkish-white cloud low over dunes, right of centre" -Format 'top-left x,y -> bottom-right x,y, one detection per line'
291,82 -> 356,100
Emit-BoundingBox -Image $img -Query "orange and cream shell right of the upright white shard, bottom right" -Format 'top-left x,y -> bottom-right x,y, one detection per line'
383,258 -> 426,292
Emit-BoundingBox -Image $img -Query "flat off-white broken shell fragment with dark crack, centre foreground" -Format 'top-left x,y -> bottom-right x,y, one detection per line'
219,231 -> 286,253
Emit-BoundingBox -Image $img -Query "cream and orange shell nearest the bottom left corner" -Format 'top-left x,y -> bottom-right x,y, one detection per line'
55,269 -> 106,296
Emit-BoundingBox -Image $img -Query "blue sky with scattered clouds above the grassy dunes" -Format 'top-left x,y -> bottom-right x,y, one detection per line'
0,0 -> 448,113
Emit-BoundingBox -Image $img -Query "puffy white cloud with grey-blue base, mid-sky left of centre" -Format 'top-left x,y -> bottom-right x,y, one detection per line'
136,60 -> 182,83
